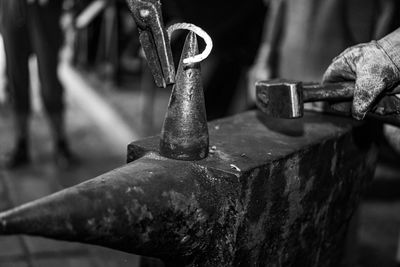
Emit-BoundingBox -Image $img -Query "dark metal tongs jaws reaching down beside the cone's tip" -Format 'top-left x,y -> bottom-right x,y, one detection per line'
126,0 -> 175,87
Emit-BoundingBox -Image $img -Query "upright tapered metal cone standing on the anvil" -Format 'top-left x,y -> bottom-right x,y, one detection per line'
160,32 -> 209,160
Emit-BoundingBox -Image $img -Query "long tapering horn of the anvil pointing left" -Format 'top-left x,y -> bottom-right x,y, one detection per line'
0,154 -> 216,266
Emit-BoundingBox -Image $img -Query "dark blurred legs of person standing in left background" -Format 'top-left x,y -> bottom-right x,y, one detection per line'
0,0 -> 74,168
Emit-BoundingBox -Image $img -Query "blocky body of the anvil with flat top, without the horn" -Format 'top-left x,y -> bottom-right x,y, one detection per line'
128,112 -> 376,266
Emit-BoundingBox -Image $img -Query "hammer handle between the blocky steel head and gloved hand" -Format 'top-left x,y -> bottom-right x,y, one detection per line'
303,82 -> 400,102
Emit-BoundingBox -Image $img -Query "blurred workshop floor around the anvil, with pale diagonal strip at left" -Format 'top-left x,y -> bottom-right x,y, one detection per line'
0,59 -> 400,267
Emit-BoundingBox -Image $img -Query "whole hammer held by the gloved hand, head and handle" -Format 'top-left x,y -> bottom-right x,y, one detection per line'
256,79 -> 400,126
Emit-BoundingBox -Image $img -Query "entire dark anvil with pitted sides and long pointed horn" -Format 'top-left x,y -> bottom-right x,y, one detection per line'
0,112 -> 376,266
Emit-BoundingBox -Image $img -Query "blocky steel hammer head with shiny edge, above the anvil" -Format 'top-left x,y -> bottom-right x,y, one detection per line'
256,79 -> 304,119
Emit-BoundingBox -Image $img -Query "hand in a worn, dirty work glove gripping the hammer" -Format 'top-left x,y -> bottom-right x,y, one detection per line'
323,29 -> 400,119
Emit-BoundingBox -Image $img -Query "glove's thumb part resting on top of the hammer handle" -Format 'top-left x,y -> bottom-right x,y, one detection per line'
322,56 -> 356,83
